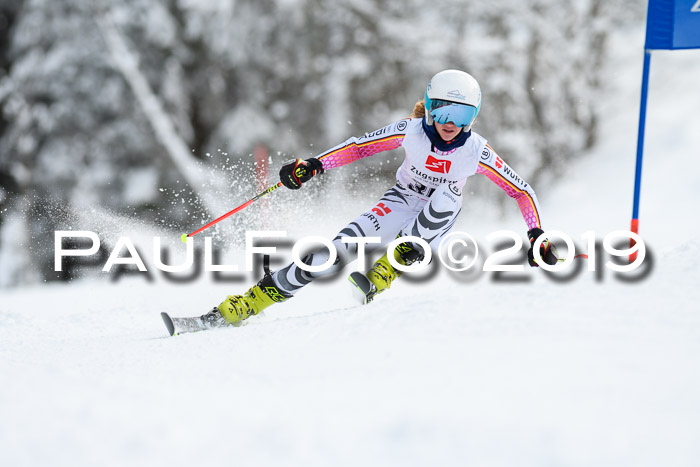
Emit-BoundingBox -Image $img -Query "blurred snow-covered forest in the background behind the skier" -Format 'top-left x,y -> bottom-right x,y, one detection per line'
0,0 -> 644,288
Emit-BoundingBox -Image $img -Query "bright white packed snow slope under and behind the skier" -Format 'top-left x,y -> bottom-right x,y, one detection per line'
0,37 -> 700,467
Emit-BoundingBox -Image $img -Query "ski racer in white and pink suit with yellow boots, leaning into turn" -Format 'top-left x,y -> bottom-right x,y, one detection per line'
201,70 -> 557,327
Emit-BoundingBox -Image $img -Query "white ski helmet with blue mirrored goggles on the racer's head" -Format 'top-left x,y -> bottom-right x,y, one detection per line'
425,70 -> 481,131
